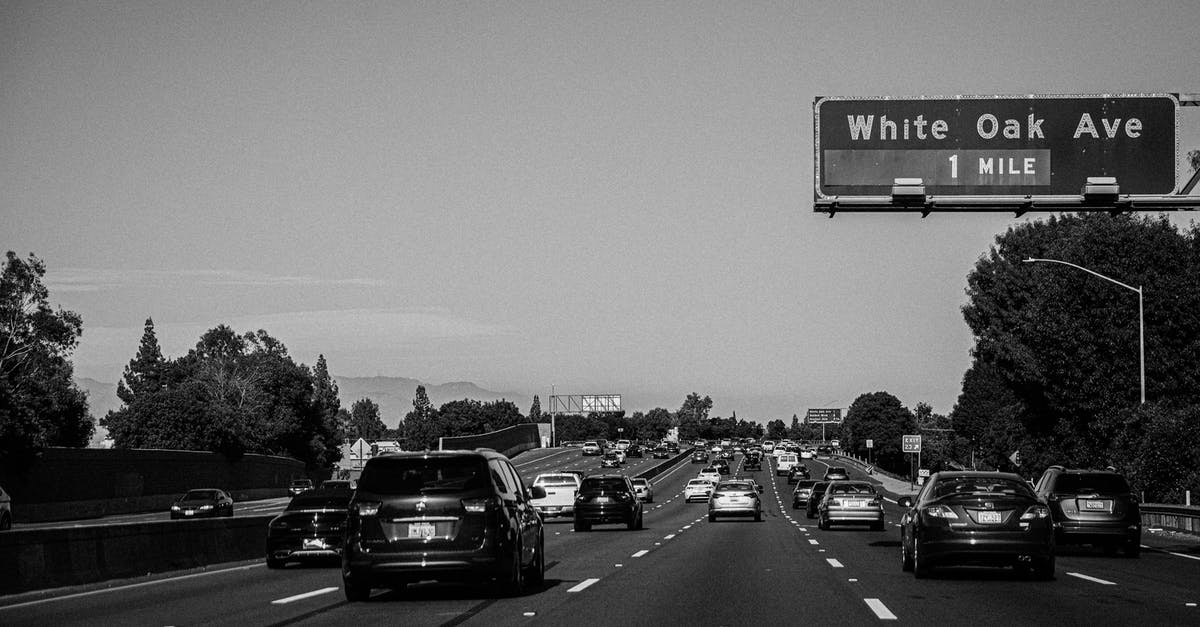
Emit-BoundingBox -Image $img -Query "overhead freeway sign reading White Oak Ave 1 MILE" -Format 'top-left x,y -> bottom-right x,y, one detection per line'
812,94 -> 1180,201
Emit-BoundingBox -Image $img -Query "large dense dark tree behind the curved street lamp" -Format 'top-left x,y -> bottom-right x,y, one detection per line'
960,213 -> 1200,474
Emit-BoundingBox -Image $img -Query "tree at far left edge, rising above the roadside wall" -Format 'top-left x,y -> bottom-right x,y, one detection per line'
0,251 -> 95,466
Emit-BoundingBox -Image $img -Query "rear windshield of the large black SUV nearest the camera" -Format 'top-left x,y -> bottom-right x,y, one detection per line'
359,456 -> 488,495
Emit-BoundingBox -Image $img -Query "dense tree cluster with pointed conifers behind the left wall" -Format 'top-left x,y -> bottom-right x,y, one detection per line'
101,320 -> 343,467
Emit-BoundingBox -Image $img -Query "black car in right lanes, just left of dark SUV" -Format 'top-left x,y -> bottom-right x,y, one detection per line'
899,471 -> 1055,579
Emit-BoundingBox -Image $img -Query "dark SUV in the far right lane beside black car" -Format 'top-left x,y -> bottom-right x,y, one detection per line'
1036,466 -> 1141,557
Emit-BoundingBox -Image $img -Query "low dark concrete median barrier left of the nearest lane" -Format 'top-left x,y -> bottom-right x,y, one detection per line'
0,515 -> 272,595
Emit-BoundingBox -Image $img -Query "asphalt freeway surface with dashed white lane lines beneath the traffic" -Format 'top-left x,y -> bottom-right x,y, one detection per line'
0,449 -> 1200,626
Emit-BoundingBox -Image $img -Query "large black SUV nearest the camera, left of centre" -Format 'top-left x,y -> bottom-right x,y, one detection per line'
342,449 -> 546,601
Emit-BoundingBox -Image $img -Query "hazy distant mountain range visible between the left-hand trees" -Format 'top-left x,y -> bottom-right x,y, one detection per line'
74,375 -> 533,432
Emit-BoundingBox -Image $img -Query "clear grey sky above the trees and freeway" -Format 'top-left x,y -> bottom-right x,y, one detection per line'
7,1 -> 1200,420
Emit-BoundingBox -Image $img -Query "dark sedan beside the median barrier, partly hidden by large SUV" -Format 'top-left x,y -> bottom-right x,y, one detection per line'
266,486 -> 354,568
